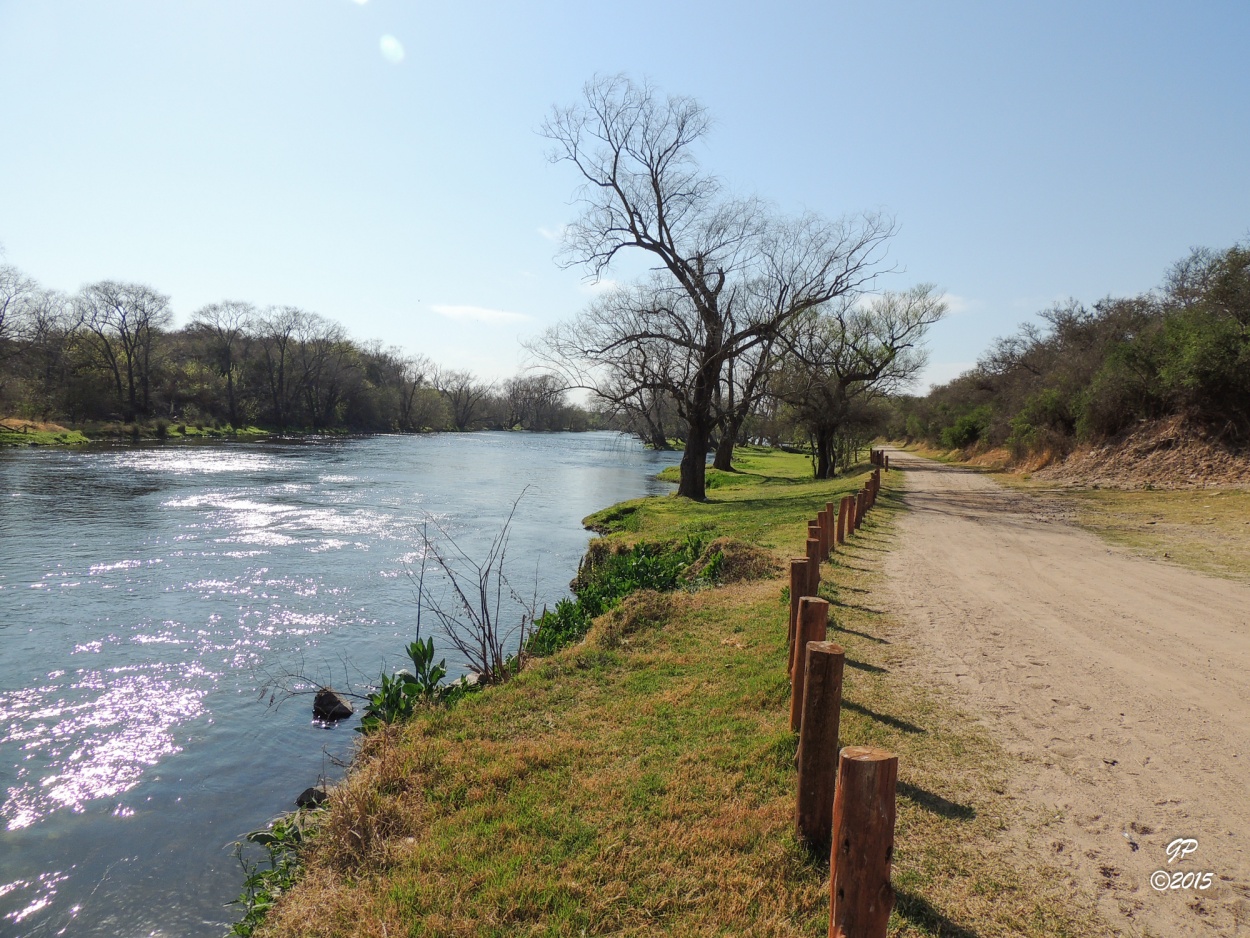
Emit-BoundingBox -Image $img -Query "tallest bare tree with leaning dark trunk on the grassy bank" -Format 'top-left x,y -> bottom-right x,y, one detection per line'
543,75 -> 893,500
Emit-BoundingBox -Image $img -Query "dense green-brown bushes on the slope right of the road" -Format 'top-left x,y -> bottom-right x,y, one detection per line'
894,244 -> 1250,456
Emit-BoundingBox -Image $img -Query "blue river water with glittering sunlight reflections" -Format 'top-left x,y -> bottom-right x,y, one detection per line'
0,433 -> 676,937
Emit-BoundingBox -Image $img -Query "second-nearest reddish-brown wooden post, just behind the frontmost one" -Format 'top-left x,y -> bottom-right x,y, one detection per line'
794,642 -> 846,847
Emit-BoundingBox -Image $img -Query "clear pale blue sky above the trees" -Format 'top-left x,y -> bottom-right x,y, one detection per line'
0,0 -> 1250,389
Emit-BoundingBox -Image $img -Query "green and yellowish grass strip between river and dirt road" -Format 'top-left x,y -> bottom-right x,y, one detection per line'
253,451 -> 1103,938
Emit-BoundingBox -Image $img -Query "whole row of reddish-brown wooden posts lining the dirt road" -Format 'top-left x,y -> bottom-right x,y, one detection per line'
789,462 -> 899,938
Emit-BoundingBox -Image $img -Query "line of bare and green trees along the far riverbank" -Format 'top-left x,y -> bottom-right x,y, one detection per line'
0,264 -> 598,431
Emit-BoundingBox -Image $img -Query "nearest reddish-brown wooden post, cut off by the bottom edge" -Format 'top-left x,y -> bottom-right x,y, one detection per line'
829,745 -> 899,938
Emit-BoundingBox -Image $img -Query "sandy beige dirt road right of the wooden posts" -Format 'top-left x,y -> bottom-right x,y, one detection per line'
888,451 -> 1250,937
